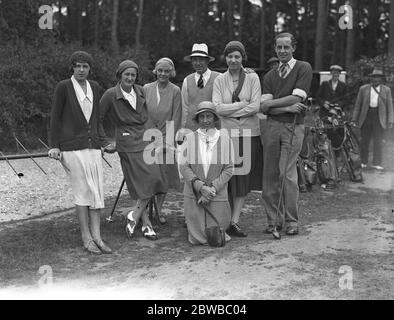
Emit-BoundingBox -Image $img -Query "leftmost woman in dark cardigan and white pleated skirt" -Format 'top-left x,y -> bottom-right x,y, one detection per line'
48,51 -> 112,254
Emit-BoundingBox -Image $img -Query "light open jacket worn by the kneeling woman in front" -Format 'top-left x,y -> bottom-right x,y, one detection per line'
180,129 -> 234,201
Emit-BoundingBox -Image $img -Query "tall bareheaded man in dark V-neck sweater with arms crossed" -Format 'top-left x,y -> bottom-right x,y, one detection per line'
260,33 -> 312,235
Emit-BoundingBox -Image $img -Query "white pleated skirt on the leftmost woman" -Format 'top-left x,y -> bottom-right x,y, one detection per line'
62,149 -> 104,209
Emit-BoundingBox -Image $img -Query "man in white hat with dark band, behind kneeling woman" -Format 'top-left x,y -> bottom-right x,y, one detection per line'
181,43 -> 220,131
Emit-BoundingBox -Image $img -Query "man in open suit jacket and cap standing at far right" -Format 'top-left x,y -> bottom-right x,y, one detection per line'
352,68 -> 394,170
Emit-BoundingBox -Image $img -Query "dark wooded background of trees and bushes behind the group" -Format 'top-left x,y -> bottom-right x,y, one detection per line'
0,0 -> 394,152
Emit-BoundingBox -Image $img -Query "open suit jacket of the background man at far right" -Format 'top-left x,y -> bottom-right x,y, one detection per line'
352,84 -> 394,129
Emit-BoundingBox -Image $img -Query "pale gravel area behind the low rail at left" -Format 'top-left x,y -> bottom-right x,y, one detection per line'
0,154 -> 127,222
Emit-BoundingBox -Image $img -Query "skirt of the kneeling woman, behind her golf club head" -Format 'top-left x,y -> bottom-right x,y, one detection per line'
184,197 -> 231,245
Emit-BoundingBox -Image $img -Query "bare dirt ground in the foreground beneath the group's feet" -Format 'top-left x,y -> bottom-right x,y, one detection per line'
0,172 -> 394,299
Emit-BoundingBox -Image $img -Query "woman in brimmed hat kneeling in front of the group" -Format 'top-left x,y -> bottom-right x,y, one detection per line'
180,101 -> 233,244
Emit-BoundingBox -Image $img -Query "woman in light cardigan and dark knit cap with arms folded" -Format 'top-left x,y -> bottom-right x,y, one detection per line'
212,41 -> 263,237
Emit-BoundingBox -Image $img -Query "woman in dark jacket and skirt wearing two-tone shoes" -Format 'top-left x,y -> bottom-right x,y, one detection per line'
100,60 -> 167,240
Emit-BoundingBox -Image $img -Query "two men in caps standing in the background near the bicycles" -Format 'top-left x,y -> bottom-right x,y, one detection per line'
316,65 -> 394,188
